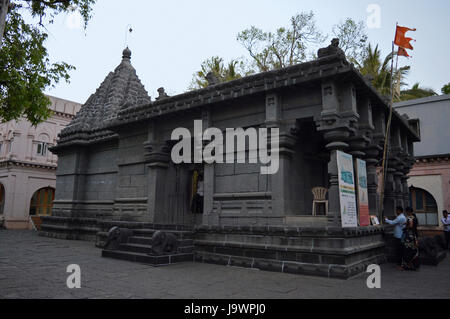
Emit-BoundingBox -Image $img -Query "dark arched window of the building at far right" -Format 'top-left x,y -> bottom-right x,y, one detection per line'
410,187 -> 439,226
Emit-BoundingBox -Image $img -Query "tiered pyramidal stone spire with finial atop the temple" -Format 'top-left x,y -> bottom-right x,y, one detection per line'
58,48 -> 151,144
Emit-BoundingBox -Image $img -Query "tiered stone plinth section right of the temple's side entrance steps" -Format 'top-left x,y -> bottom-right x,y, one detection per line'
194,227 -> 386,279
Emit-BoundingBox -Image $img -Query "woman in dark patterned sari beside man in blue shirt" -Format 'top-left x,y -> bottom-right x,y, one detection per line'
402,216 -> 419,270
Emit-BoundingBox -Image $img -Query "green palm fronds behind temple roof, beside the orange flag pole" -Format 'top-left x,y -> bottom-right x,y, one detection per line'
354,43 -> 410,100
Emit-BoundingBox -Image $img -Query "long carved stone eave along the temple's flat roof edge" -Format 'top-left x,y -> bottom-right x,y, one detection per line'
106,55 -> 420,142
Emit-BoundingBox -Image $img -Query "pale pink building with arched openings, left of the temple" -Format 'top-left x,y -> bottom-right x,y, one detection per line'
0,96 -> 81,229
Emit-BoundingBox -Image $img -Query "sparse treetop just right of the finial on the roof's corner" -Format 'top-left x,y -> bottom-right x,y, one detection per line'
332,18 -> 368,62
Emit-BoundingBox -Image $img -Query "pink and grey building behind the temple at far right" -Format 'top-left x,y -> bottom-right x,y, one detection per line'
395,95 -> 450,231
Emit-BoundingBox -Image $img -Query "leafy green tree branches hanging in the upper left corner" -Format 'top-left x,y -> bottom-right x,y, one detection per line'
0,0 -> 95,125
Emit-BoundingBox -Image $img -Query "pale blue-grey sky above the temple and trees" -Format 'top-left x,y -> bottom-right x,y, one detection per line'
31,0 -> 450,104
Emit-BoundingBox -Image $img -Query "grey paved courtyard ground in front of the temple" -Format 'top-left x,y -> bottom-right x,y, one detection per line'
0,230 -> 450,299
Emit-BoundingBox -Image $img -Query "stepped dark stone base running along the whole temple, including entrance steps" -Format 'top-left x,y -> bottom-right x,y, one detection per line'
41,217 -> 408,279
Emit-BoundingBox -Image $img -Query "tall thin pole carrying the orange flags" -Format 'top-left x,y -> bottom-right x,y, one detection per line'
380,23 -> 398,222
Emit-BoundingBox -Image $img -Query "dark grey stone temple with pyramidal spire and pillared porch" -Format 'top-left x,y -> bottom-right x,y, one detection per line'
41,44 -> 420,278
